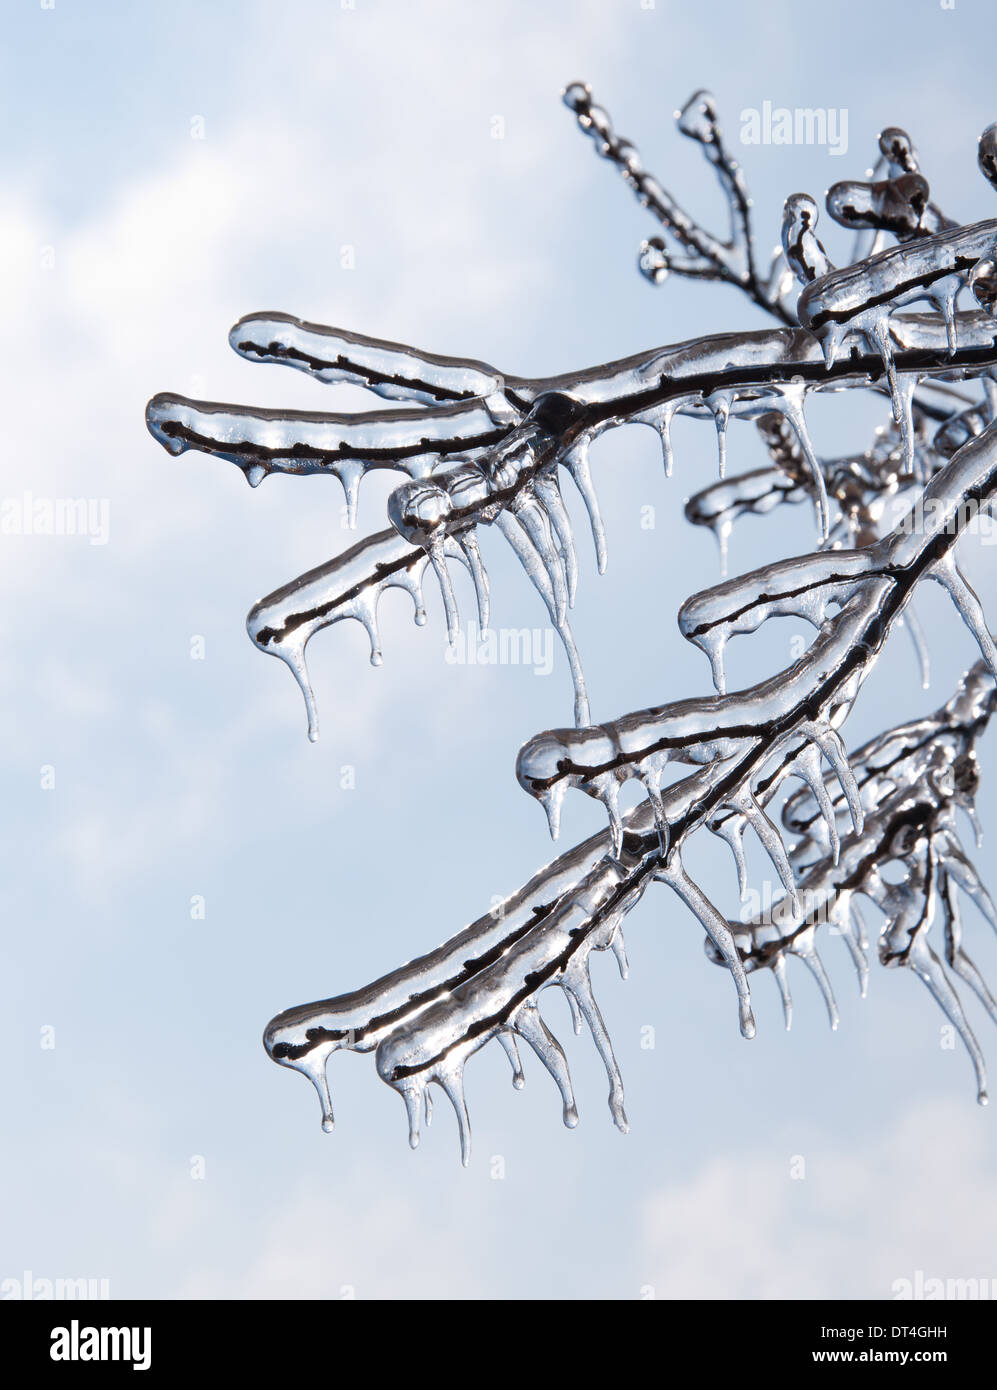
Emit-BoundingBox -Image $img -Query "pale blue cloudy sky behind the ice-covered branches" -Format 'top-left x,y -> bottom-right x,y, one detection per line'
0,0 -> 997,1298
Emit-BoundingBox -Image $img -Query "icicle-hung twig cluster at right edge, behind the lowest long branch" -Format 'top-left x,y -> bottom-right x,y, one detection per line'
712,662 -> 997,1104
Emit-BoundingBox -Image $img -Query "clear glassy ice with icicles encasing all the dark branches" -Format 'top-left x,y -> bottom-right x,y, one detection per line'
146,82 -> 997,1162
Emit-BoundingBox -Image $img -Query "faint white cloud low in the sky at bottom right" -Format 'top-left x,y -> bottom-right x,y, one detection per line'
640,1101 -> 997,1298
